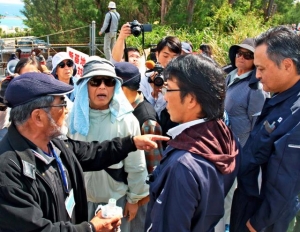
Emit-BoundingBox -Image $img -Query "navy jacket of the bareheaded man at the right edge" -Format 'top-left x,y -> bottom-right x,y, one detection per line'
237,81 -> 300,231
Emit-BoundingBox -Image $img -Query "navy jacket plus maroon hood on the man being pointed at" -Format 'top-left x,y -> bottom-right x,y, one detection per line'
145,121 -> 238,232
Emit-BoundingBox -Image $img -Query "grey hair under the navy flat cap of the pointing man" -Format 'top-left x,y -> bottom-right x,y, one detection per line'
10,96 -> 54,126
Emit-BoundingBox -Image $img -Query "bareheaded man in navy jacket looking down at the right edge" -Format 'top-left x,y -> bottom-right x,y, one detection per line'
230,26 -> 300,232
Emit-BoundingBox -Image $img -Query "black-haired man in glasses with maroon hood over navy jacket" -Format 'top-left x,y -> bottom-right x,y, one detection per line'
146,54 -> 238,232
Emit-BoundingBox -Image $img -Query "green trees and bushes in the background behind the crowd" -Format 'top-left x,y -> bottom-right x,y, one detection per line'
1,0 -> 300,65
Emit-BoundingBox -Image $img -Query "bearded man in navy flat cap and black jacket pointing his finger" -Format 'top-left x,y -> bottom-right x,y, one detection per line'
0,73 -> 169,232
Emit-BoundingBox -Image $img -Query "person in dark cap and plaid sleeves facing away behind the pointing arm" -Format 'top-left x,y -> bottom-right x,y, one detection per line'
115,62 -> 163,232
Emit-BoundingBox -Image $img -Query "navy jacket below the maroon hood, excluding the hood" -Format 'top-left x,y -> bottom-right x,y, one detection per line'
146,146 -> 224,232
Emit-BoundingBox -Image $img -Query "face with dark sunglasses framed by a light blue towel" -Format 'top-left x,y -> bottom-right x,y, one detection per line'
88,76 -> 116,110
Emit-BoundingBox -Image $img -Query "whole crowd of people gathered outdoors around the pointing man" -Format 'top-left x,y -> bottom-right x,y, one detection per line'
0,2 -> 300,232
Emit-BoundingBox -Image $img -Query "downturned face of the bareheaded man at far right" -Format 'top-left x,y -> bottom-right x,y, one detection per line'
254,44 -> 295,93
